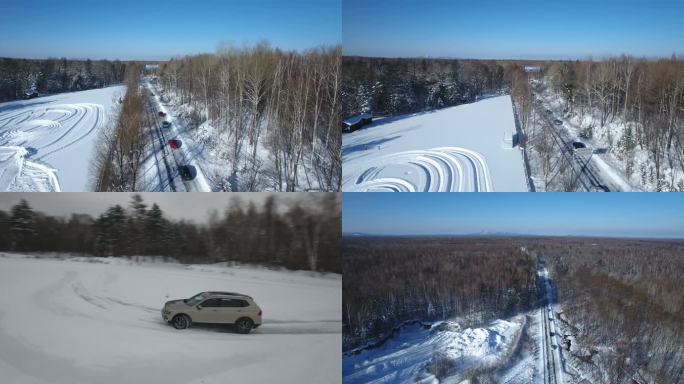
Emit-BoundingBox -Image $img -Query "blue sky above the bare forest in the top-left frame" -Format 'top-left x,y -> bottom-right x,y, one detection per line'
0,0 -> 342,60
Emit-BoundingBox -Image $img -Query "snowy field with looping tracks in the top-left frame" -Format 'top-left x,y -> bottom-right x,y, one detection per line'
0,86 -> 124,191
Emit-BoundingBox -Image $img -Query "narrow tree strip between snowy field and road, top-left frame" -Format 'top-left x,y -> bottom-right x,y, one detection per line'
91,64 -> 150,192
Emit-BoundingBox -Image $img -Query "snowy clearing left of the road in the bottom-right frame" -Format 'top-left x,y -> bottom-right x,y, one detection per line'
342,316 -> 536,384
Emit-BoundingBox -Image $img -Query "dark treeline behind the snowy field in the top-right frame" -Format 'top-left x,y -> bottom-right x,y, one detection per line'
341,56 -> 516,117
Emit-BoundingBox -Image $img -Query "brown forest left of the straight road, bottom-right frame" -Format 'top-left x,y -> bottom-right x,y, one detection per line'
342,237 -> 537,349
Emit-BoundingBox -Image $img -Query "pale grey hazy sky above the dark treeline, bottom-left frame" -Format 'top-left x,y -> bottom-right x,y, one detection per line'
0,192 -> 313,222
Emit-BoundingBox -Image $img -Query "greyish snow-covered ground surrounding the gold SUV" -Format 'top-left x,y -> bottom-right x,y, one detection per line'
0,254 -> 342,384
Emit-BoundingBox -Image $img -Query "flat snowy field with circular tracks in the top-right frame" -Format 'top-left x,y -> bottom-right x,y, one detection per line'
342,96 -> 528,192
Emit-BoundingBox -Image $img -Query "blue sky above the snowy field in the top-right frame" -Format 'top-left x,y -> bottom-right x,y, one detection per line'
342,0 -> 684,59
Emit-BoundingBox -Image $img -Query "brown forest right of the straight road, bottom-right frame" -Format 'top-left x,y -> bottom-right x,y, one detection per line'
530,239 -> 684,384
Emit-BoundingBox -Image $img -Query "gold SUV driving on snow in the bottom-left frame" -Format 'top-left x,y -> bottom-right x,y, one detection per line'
162,292 -> 261,333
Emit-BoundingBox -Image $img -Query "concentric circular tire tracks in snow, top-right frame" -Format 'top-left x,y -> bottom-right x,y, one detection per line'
349,147 -> 494,192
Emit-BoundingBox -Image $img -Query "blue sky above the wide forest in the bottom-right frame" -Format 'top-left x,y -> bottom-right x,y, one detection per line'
342,193 -> 684,238
